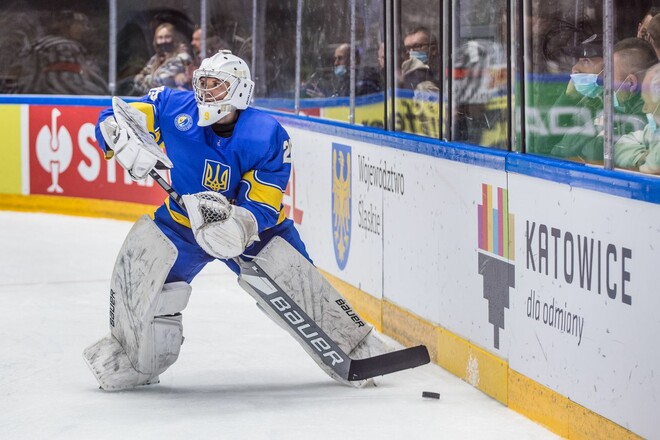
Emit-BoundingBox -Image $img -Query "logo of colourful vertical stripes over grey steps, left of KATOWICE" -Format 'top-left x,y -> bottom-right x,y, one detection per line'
477,184 -> 515,349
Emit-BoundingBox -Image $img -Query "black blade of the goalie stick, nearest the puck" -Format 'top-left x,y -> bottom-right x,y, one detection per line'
347,345 -> 431,381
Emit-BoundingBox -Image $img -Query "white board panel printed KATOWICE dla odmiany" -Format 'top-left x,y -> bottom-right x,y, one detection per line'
509,174 -> 660,438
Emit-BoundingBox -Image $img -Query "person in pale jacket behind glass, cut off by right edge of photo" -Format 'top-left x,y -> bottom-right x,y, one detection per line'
614,64 -> 660,174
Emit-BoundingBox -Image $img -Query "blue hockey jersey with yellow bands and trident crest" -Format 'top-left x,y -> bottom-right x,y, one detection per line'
96,87 -> 291,233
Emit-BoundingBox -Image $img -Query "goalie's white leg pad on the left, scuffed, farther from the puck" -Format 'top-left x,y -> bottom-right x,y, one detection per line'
83,216 -> 191,390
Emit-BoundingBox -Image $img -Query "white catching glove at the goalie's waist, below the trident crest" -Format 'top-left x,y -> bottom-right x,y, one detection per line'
183,191 -> 259,259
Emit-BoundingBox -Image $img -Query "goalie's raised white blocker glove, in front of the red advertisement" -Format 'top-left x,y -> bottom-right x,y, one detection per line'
100,116 -> 158,180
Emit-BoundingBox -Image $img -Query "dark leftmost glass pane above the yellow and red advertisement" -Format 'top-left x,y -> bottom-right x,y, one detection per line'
0,1 -> 108,95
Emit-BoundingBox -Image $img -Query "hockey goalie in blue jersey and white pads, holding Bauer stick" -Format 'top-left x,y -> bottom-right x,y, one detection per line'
83,51 -> 429,390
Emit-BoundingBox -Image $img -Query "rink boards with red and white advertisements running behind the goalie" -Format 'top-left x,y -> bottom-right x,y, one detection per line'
0,98 -> 660,438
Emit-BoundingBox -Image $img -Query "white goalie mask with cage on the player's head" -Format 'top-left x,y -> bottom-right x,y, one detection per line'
193,50 -> 254,127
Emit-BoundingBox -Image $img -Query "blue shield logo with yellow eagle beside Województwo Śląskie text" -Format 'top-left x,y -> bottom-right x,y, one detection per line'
332,142 -> 352,270
